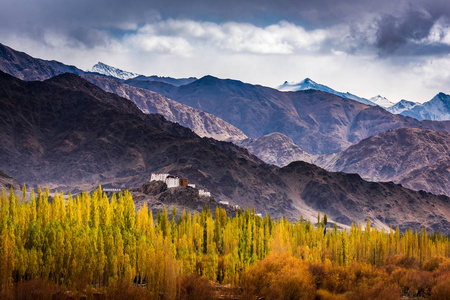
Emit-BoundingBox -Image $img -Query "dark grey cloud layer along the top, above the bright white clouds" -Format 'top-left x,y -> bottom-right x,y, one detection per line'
0,0 -> 450,56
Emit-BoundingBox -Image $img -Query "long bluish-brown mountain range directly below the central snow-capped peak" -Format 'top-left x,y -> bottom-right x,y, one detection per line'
125,76 -> 450,154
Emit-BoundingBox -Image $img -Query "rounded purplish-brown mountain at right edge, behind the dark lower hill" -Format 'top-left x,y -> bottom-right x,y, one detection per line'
326,128 -> 450,196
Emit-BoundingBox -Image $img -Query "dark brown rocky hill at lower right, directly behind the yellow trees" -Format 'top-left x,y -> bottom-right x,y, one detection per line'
279,162 -> 450,234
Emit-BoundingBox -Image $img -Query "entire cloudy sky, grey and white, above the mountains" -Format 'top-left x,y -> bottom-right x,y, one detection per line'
0,0 -> 450,102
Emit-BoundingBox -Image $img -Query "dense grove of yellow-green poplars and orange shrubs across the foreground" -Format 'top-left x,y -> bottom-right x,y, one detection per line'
0,186 -> 450,299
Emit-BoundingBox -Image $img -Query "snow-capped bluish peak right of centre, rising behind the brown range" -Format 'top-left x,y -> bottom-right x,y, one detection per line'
277,78 -> 377,106
